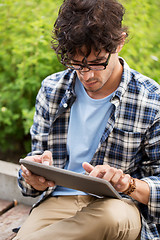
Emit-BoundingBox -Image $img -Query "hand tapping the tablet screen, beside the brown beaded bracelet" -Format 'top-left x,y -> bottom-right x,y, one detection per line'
82,162 -> 131,192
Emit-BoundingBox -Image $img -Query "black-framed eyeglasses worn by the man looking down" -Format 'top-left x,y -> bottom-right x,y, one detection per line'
65,53 -> 111,72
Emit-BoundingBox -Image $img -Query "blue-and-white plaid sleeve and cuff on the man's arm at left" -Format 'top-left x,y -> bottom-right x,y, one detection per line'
18,79 -> 50,197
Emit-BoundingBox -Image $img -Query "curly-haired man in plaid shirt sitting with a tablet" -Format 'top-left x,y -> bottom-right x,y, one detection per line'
15,0 -> 160,240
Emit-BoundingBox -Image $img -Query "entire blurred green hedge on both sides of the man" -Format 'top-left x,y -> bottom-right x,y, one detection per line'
0,0 -> 160,156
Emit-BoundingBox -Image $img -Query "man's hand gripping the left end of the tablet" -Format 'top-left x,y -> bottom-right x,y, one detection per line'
21,151 -> 55,191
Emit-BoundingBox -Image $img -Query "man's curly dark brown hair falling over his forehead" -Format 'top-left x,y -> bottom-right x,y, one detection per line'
52,0 -> 127,64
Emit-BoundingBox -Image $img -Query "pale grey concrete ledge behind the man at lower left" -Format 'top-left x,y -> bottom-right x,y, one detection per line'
0,161 -> 38,205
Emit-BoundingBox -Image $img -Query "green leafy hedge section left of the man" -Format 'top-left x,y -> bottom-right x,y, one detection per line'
0,0 -> 62,151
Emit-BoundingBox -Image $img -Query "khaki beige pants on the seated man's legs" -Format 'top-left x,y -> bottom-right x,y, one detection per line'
14,196 -> 141,240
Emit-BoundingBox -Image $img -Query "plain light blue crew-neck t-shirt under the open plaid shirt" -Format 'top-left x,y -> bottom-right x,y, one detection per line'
53,78 -> 113,196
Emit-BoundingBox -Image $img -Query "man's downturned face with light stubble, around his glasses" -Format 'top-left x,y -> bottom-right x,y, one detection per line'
72,50 -> 122,99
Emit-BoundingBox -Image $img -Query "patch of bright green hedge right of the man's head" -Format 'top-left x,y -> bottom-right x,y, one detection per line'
121,0 -> 160,83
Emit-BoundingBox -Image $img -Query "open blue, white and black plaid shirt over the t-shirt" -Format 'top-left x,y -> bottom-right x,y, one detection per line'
19,59 -> 160,240
